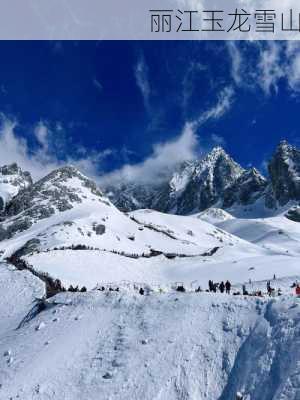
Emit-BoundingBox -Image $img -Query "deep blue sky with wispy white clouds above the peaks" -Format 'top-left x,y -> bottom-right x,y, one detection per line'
0,41 -> 300,183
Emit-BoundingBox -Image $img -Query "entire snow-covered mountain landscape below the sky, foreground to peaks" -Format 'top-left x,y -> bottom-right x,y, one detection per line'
0,144 -> 300,400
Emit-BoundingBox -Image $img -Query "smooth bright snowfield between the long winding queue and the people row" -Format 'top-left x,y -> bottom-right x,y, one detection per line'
24,248 -> 300,289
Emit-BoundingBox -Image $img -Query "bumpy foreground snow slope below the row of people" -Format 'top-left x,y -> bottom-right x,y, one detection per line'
0,282 -> 300,400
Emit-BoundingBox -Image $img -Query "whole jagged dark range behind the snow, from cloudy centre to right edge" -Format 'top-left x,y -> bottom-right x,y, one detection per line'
105,141 -> 300,216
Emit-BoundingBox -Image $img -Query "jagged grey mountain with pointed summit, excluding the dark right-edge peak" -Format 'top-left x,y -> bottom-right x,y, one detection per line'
108,147 -> 244,215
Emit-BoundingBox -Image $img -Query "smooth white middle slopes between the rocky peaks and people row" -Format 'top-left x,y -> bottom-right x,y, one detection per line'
4,202 -> 299,289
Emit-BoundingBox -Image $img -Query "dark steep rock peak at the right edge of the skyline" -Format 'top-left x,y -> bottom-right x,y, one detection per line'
269,141 -> 300,206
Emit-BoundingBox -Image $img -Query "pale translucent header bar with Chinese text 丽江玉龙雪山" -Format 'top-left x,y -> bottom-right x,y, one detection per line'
0,0 -> 300,40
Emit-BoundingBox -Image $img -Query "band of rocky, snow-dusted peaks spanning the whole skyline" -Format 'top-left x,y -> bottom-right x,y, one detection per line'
0,141 -> 300,234
